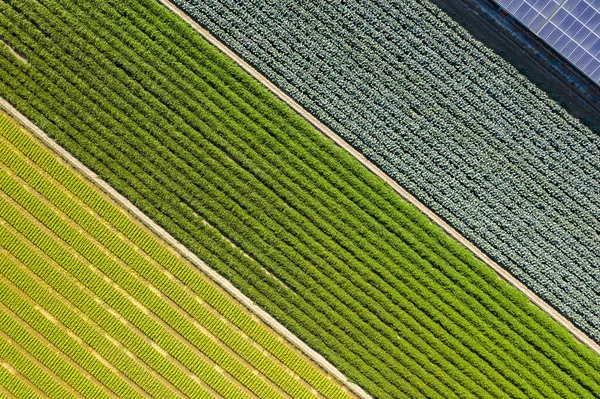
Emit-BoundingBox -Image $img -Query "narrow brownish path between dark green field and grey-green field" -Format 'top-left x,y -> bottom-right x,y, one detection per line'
152,0 -> 600,355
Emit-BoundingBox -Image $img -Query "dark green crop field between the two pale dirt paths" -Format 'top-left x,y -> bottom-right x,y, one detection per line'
0,0 -> 600,399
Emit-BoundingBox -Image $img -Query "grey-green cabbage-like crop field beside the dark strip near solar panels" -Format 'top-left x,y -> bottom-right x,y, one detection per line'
175,0 -> 600,342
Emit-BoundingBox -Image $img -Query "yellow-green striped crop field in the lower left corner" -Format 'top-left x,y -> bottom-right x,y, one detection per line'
0,115 -> 352,399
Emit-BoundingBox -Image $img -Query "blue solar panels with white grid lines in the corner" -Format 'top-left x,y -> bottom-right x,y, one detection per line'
496,0 -> 600,85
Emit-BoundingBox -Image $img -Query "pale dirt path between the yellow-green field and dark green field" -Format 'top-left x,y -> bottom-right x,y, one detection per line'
0,99 -> 372,399
